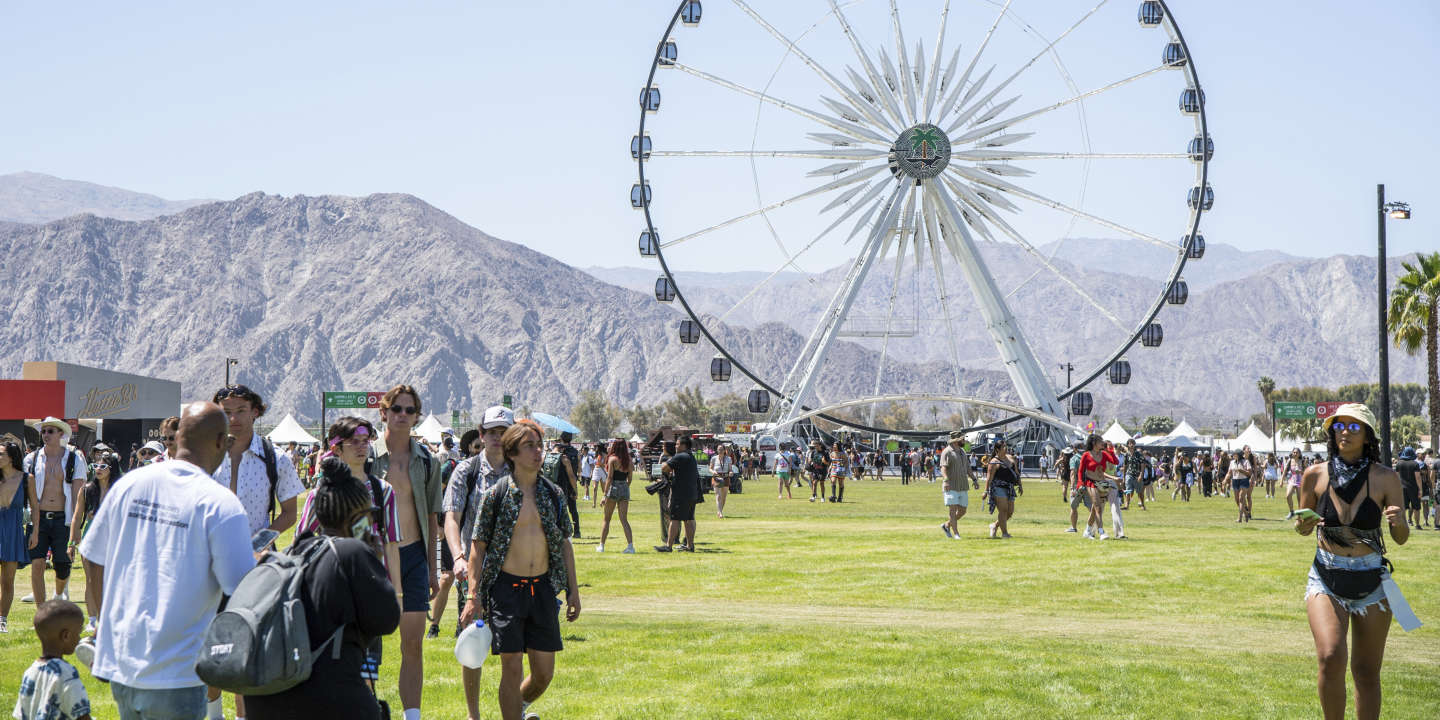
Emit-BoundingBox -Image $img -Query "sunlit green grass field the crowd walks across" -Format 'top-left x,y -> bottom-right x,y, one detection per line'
0,478 -> 1440,720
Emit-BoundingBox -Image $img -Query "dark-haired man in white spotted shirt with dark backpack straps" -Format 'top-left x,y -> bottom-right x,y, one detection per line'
213,384 -> 305,536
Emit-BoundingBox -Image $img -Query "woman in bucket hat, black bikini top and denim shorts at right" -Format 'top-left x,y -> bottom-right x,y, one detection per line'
1295,403 -> 1410,720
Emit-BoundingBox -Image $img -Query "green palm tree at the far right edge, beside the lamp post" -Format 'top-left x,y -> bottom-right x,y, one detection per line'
1385,252 -> 1440,448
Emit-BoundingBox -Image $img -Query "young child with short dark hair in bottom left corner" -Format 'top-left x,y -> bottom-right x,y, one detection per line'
14,598 -> 89,720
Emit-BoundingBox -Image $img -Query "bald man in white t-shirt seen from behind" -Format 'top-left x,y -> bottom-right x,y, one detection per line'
81,403 -> 255,720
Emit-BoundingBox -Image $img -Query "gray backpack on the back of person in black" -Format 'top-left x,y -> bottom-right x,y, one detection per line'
194,537 -> 346,696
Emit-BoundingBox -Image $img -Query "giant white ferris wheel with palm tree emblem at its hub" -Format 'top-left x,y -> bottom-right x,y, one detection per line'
631,0 -> 1214,435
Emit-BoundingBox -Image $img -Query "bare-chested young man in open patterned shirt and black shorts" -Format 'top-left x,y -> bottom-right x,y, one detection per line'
461,420 -> 580,720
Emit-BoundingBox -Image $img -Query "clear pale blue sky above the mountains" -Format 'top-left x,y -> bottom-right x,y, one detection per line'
0,0 -> 1440,269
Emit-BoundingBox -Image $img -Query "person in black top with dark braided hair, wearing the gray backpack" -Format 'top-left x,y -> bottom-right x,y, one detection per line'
245,458 -> 400,720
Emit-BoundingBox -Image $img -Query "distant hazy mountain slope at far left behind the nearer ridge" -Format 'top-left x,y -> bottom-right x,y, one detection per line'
0,173 -> 209,223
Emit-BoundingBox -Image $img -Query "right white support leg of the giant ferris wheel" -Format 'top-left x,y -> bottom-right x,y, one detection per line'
926,183 -> 1063,416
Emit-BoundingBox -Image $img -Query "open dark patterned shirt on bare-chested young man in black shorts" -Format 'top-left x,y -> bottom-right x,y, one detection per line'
471,474 -> 570,603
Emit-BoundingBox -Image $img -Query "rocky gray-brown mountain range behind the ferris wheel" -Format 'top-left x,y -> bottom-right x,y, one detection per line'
0,173 -> 1423,428
